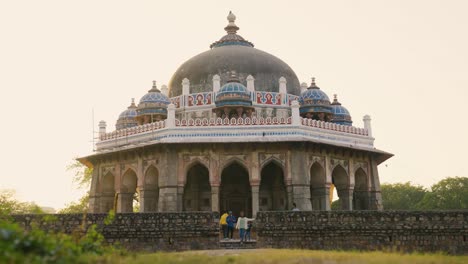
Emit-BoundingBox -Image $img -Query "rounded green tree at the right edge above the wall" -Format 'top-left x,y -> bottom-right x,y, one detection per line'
421,177 -> 468,210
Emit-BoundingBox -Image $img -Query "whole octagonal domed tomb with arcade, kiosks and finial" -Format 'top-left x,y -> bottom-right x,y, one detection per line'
79,13 -> 392,216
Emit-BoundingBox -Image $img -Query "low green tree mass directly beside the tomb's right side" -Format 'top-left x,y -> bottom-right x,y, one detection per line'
380,182 -> 427,210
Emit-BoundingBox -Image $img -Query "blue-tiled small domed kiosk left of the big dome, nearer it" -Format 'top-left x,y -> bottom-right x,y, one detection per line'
137,81 -> 171,115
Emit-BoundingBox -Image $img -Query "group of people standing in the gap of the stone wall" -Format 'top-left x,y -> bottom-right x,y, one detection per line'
219,211 -> 255,243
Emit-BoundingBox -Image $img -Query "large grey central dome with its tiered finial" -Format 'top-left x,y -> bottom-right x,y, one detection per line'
169,13 -> 300,97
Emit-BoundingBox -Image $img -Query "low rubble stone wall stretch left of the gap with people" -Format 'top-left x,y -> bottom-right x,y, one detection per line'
14,212 -> 219,251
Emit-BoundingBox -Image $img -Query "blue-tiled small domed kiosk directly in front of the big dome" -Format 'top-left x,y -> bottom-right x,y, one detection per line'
215,73 -> 252,107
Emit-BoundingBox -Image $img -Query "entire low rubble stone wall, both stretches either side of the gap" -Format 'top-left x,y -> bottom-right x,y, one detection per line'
11,211 -> 468,254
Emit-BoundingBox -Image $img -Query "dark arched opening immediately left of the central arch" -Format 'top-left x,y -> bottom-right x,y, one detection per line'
183,163 -> 211,211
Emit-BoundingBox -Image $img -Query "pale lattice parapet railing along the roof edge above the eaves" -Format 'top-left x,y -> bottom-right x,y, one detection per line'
100,117 -> 369,141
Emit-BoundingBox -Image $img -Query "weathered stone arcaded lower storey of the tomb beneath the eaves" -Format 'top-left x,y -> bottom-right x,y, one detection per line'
87,142 -> 388,216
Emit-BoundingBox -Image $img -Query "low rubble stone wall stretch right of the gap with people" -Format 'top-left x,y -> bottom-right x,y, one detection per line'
255,211 -> 468,254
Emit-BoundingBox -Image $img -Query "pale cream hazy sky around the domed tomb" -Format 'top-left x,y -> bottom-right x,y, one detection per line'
0,0 -> 468,208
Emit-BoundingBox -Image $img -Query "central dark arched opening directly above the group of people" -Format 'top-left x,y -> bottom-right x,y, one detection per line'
219,162 -> 252,217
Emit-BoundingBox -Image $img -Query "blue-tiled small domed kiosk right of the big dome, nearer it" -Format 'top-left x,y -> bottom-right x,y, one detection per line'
299,78 -> 333,118
